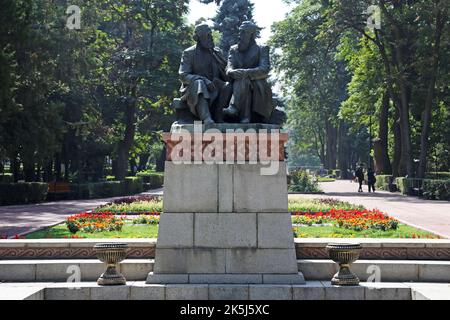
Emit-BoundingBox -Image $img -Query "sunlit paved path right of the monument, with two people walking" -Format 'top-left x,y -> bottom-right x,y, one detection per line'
301,180 -> 450,238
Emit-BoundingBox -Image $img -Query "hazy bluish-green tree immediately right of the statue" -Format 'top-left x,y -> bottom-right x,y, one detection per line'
270,1 -> 349,174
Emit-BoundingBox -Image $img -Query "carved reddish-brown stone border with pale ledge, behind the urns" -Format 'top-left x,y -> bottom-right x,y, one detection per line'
0,239 -> 450,261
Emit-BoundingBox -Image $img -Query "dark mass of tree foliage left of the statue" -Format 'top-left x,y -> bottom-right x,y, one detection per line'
0,0 -> 192,183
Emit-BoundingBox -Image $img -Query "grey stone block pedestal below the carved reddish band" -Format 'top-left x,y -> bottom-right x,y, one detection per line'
147,124 -> 304,284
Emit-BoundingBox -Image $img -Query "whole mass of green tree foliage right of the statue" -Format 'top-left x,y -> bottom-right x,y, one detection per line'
271,0 -> 450,177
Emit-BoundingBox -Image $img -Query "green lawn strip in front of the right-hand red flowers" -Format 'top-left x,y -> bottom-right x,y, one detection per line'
294,225 -> 439,239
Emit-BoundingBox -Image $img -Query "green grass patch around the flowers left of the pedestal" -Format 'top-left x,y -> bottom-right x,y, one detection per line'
25,220 -> 158,239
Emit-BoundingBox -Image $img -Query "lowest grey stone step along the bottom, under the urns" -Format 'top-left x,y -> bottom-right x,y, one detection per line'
0,281 -> 450,300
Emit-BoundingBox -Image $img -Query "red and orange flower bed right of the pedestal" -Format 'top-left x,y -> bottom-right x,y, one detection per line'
293,209 -> 398,231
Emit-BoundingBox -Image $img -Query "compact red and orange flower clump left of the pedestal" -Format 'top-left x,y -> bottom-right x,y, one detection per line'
66,212 -> 124,234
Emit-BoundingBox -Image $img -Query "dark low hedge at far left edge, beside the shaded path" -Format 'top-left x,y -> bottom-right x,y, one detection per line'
0,182 -> 48,205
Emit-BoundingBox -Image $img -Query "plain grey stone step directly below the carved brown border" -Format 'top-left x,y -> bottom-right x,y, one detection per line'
0,259 -> 450,283
